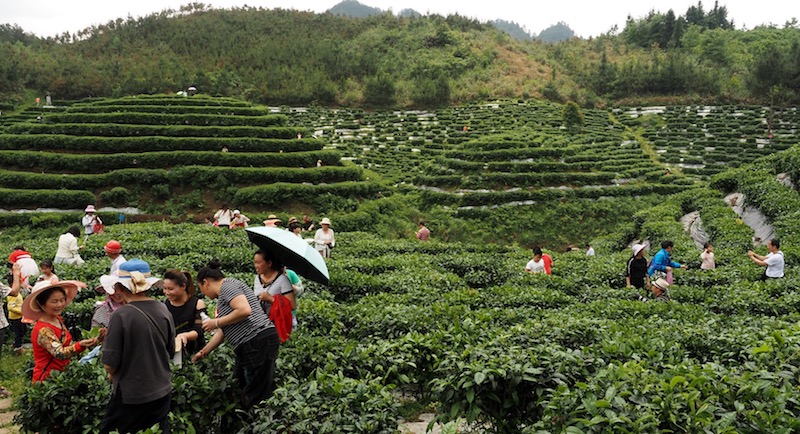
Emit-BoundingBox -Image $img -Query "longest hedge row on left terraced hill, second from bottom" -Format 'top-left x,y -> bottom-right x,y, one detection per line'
0,166 -> 362,190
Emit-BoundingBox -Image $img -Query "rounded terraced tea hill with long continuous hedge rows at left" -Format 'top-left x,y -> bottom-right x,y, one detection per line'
0,96 -> 378,213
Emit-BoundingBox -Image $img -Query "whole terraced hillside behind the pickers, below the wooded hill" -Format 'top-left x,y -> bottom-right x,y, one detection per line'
0,96 -> 797,248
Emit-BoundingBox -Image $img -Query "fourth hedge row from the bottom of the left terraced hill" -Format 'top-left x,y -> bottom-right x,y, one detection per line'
0,134 -> 323,153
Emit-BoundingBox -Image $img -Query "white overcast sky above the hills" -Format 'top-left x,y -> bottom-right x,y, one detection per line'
0,0 -> 800,37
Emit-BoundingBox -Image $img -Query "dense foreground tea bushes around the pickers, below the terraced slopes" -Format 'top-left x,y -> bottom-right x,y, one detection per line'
0,175 -> 800,433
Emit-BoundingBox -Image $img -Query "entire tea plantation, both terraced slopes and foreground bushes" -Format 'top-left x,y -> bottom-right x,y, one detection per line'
0,97 -> 800,434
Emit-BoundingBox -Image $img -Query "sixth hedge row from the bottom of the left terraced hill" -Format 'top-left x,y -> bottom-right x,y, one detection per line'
45,112 -> 286,127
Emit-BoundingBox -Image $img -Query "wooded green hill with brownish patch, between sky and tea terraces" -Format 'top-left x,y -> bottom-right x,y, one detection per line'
0,4 -> 800,107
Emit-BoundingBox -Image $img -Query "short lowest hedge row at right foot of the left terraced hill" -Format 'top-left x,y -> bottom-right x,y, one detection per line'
233,182 -> 384,208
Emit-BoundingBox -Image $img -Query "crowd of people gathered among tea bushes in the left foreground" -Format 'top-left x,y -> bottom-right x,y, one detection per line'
0,219 -> 310,433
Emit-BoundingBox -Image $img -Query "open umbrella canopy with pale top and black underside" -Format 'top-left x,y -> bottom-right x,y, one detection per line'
246,226 -> 330,285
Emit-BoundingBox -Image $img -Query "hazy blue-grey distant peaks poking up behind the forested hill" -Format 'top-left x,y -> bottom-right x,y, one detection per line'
328,0 -> 575,42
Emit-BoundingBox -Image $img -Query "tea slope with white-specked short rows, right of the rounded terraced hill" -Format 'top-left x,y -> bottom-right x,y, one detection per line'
281,101 -> 708,212
